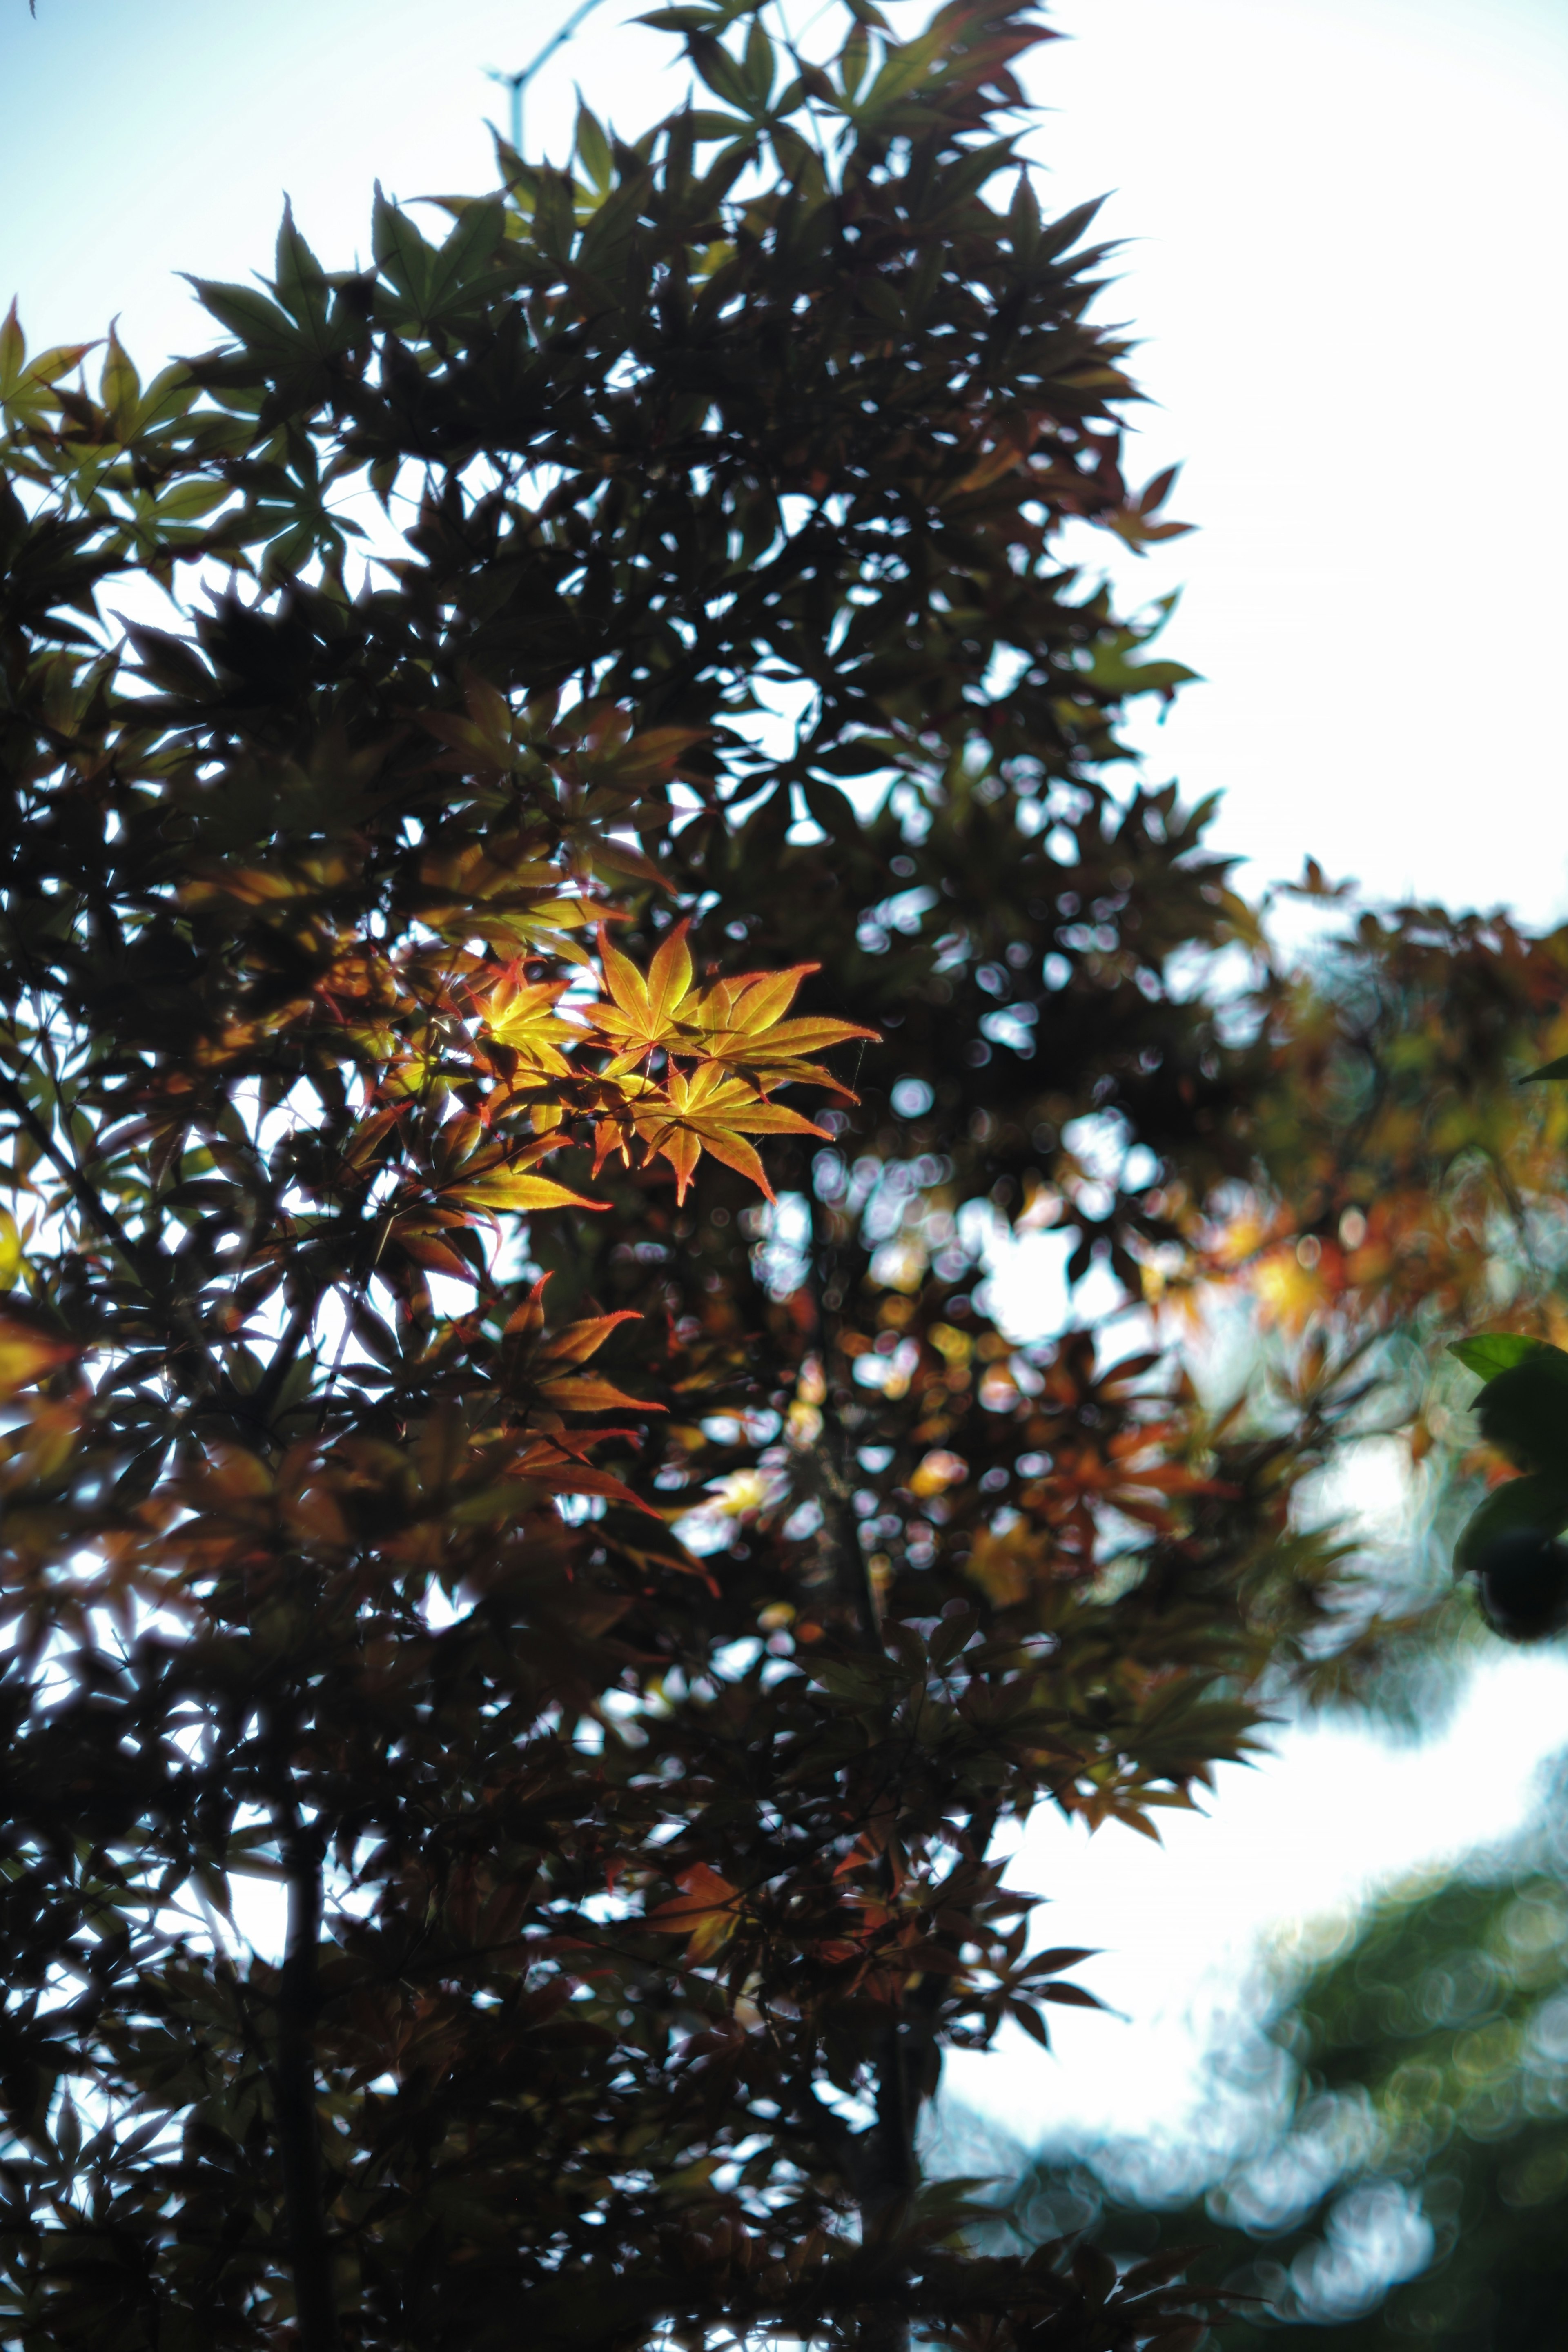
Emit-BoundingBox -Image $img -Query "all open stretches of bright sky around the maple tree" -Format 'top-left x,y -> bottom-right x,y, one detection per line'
0,0 -> 1568,2138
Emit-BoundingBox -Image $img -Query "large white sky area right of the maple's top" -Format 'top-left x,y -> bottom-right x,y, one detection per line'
1037,0 -> 1568,922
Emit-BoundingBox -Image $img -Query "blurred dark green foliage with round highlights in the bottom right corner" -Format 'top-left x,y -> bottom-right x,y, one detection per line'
973,1780 -> 1568,2352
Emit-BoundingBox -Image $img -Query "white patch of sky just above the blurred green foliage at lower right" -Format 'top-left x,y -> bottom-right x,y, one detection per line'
945,1644 -> 1568,2173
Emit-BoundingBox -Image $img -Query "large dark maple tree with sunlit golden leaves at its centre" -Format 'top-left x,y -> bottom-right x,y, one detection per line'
0,0 -> 1551,2352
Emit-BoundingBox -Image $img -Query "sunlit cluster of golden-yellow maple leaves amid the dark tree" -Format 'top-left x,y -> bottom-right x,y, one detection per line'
186,828 -> 875,1326
